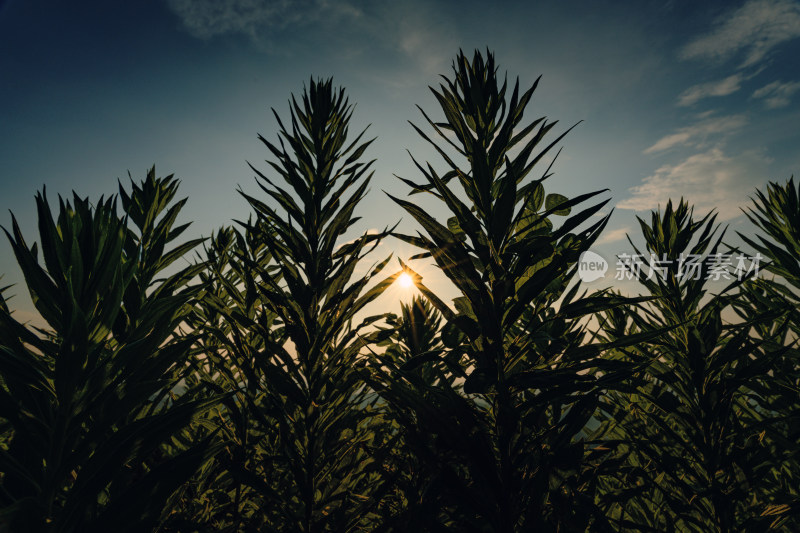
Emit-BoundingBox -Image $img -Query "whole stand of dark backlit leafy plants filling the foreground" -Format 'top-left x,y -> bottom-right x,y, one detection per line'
0,48 -> 800,533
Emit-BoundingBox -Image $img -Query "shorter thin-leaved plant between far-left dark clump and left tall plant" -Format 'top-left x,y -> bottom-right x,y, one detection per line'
155,220 -> 283,532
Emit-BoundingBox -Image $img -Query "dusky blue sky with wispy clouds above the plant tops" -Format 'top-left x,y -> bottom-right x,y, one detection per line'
0,0 -> 800,318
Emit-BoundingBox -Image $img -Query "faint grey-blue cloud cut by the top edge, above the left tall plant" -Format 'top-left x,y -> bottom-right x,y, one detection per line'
167,0 -> 361,40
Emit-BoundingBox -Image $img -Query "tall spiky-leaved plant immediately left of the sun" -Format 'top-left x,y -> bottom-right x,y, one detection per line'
214,80 -> 404,532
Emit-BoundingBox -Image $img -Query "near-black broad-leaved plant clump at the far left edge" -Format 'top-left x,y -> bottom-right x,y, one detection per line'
0,169 -> 217,532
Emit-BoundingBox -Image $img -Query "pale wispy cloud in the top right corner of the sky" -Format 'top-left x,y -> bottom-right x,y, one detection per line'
681,0 -> 800,68
